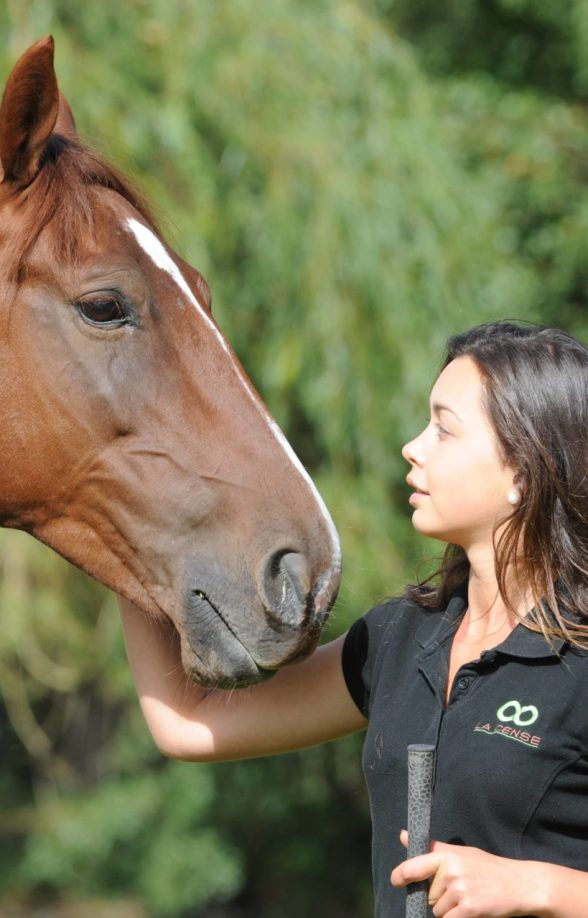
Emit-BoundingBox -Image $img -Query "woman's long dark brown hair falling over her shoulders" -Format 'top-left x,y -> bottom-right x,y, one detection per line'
407,322 -> 588,649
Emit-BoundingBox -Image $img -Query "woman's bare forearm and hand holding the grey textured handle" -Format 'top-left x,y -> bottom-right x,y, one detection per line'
392,832 -> 588,918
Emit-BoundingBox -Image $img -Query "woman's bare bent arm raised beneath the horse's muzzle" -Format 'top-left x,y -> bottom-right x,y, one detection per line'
119,598 -> 366,762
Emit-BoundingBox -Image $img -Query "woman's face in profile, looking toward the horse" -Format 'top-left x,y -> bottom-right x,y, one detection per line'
402,357 -> 516,551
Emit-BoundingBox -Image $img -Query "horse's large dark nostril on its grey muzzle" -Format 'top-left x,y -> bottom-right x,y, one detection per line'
261,550 -> 311,625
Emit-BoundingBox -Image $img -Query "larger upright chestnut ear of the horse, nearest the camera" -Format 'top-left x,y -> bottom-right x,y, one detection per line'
0,36 -> 59,187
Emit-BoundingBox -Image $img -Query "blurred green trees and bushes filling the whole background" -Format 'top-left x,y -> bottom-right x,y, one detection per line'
0,0 -> 588,918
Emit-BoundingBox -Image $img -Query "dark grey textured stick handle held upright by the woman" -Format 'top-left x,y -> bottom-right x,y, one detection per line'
406,744 -> 435,918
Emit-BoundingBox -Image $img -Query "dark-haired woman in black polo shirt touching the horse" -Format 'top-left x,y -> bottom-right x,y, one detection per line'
122,323 -> 588,918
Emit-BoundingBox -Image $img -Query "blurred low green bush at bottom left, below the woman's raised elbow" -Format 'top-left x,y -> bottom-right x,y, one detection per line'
17,763 -> 242,916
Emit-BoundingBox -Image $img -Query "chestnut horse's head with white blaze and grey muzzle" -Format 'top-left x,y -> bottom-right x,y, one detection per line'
0,37 -> 340,687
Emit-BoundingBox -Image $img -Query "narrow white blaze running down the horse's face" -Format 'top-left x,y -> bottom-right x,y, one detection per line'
126,217 -> 341,567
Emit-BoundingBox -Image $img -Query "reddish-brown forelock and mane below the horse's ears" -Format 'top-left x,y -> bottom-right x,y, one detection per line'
2,134 -> 160,279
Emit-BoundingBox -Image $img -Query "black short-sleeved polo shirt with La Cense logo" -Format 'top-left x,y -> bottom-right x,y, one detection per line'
343,595 -> 588,918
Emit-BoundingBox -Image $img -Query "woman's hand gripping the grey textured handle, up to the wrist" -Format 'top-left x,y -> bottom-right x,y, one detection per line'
391,831 -> 548,918
